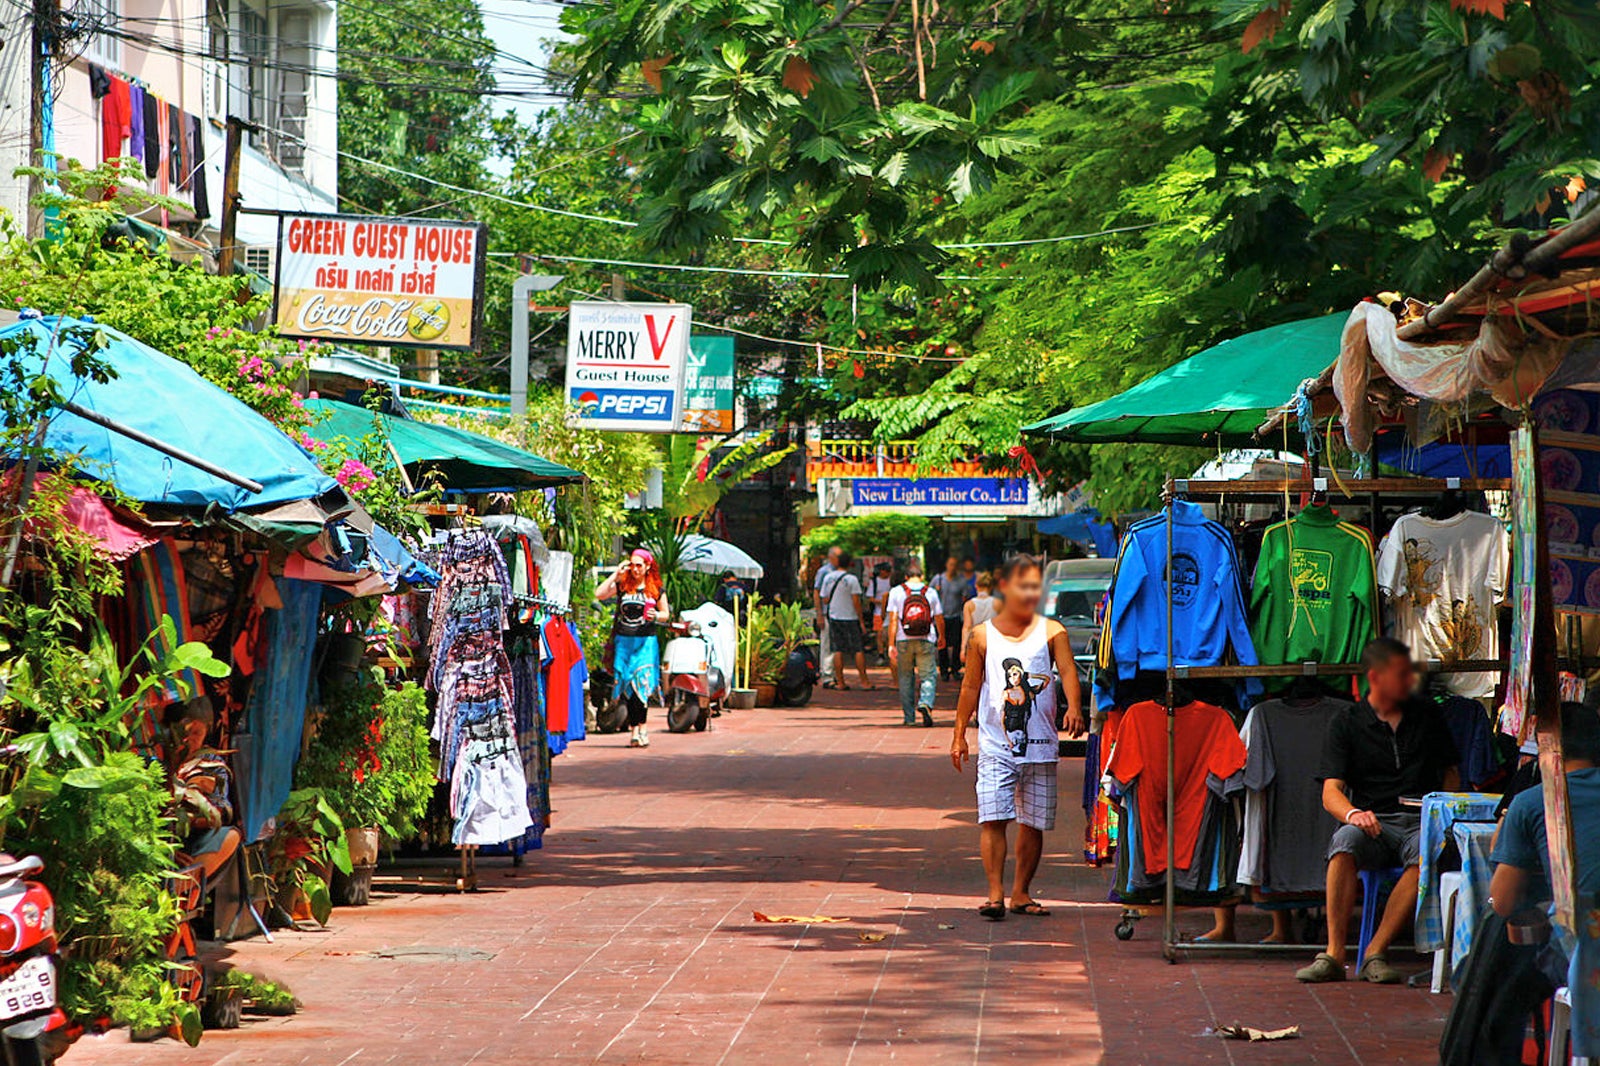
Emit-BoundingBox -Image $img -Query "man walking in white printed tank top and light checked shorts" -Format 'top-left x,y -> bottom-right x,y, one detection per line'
950,555 -> 1083,922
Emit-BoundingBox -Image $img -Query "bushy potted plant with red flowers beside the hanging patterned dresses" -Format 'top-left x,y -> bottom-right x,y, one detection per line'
294,669 -> 434,906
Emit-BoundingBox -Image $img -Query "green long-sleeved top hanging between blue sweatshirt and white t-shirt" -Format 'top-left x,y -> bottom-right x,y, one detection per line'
1250,504 -> 1378,663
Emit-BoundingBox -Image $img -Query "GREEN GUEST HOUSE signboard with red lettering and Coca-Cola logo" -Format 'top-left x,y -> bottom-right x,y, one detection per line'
274,214 -> 486,349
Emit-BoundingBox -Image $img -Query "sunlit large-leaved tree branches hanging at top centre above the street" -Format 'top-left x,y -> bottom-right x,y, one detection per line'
565,0 -> 1132,290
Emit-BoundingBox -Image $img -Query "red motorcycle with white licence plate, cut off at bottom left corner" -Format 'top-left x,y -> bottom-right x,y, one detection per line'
0,853 -> 80,1066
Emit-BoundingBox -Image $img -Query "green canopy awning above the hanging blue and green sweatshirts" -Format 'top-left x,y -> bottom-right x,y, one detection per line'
1022,311 -> 1350,445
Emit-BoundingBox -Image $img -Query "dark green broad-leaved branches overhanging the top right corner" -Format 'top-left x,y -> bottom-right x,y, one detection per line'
1218,0 -> 1600,224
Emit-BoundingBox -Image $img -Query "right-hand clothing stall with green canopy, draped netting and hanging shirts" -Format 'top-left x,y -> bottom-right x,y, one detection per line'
1030,203 -> 1600,1055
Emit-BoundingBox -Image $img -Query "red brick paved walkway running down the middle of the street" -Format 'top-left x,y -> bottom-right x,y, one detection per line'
66,675 -> 1450,1066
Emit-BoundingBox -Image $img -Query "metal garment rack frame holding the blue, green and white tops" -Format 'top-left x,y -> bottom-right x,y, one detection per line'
1162,477 -> 1510,962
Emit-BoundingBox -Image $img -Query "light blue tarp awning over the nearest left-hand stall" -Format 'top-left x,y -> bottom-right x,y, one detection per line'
0,315 -> 338,511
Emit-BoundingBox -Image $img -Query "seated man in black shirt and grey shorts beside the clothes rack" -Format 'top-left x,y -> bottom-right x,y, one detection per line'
1294,637 -> 1459,984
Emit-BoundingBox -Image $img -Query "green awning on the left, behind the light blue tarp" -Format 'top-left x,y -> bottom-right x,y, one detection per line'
306,400 -> 584,493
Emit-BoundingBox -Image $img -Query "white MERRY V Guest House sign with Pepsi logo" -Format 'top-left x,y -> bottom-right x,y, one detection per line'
566,301 -> 693,434
